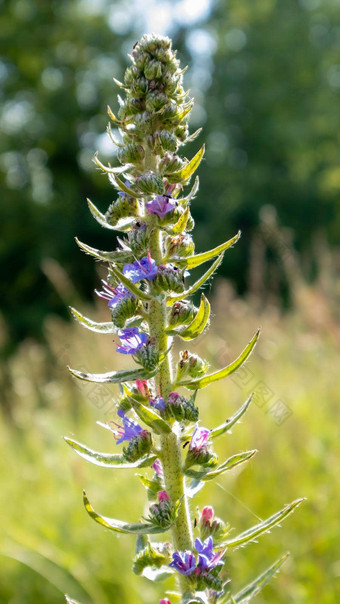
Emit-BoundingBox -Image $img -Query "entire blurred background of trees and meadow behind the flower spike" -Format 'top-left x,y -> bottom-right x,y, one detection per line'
0,0 -> 340,604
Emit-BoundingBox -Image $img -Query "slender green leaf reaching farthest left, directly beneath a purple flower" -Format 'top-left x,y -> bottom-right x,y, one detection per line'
64,436 -> 156,470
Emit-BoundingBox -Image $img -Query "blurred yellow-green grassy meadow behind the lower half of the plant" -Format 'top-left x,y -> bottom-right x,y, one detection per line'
0,266 -> 340,604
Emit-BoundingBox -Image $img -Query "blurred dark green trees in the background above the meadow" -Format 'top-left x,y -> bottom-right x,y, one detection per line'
0,0 -> 340,352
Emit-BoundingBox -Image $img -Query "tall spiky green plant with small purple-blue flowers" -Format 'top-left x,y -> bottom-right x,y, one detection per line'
66,35 -> 302,604
